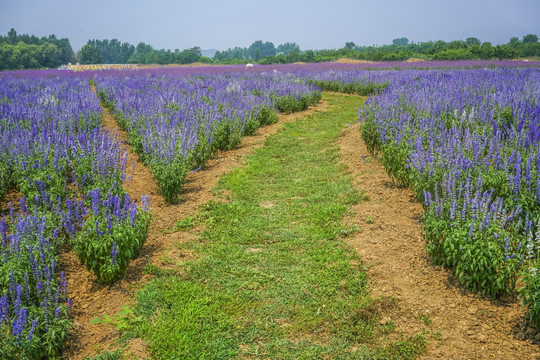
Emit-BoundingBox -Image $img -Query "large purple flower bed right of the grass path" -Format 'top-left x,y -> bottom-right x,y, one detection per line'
358,67 -> 540,325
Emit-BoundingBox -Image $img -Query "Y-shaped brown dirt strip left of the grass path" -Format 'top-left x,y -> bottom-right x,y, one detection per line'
63,94 -> 328,359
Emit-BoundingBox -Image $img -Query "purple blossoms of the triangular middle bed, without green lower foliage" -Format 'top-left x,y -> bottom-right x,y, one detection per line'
95,70 -> 317,164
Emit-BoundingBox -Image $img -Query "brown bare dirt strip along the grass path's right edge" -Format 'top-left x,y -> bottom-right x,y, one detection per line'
339,125 -> 540,359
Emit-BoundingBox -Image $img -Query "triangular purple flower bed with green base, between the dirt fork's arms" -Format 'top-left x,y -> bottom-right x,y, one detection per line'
94,69 -> 321,203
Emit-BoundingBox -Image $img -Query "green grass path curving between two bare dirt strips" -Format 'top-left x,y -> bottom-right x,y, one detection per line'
127,93 -> 425,359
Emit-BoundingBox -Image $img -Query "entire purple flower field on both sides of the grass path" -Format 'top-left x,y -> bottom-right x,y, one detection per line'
0,61 -> 540,358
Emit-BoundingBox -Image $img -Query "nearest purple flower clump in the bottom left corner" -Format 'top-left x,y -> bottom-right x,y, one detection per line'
0,213 -> 67,343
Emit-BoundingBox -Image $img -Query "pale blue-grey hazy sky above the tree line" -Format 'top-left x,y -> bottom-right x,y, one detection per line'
0,0 -> 540,51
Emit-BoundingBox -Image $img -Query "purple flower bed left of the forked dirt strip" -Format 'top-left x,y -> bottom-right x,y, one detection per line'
0,73 -> 149,358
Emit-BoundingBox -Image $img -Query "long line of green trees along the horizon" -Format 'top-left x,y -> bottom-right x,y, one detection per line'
0,29 -> 540,70
